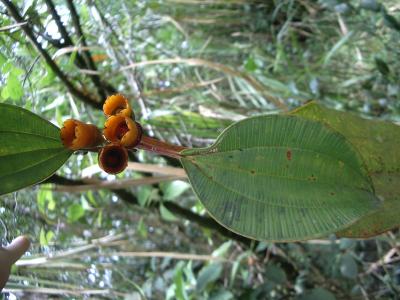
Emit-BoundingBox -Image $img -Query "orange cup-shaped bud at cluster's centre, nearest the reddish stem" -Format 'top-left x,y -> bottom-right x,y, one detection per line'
103,115 -> 142,148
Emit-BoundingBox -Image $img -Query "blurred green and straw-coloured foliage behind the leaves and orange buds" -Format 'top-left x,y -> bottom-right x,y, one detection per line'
0,0 -> 400,299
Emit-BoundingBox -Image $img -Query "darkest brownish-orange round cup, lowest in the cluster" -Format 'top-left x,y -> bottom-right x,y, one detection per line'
99,144 -> 128,174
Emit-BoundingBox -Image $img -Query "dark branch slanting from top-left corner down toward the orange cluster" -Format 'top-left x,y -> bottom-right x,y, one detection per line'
0,0 -> 102,109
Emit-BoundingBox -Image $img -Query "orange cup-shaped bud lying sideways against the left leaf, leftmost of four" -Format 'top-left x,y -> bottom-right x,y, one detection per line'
60,119 -> 103,150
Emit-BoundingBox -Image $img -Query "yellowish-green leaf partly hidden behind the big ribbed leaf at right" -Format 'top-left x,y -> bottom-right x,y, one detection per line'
292,102 -> 400,238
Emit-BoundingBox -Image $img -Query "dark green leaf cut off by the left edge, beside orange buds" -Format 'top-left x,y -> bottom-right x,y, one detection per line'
0,104 -> 72,195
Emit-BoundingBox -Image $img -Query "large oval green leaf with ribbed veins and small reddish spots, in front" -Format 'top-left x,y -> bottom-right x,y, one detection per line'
181,115 -> 378,241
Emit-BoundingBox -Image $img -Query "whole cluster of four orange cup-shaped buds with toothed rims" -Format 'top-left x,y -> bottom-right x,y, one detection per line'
61,94 -> 142,174
